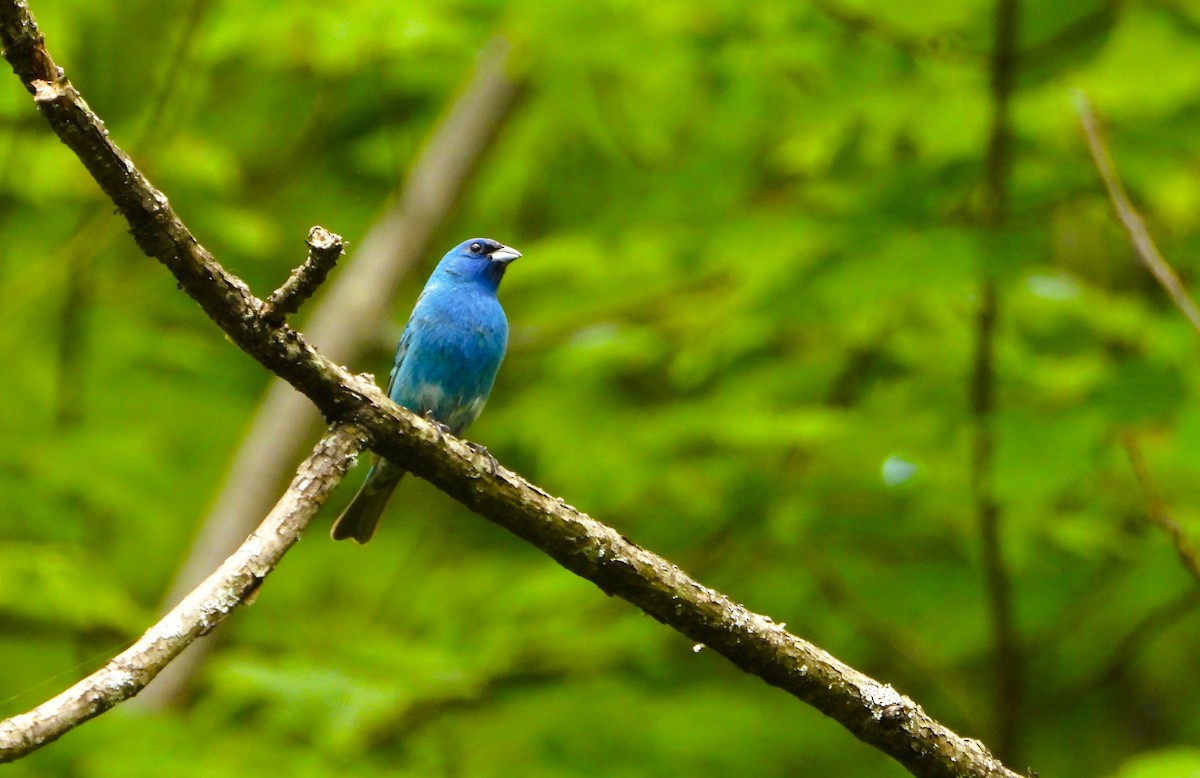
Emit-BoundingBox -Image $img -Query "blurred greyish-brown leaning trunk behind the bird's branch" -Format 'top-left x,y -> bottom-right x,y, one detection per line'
137,44 -> 517,708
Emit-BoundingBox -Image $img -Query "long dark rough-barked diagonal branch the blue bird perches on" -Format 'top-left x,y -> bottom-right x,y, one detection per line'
0,0 -> 1018,778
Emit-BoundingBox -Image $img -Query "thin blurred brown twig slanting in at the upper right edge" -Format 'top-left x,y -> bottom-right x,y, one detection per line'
1074,91 -> 1200,334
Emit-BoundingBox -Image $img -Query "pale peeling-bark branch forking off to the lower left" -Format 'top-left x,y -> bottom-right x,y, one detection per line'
0,426 -> 366,762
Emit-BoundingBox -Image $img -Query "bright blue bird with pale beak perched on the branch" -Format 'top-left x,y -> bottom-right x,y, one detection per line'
330,238 -> 521,543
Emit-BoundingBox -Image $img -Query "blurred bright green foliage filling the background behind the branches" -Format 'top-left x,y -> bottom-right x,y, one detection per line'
0,0 -> 1200,778
